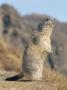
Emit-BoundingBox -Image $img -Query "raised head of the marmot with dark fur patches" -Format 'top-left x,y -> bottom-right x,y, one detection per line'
35,18 -> 56,35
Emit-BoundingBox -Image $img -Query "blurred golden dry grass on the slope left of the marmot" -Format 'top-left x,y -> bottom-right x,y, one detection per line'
0,39 -> 21,71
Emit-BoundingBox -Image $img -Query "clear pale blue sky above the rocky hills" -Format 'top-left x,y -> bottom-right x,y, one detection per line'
0,0 -> 67,22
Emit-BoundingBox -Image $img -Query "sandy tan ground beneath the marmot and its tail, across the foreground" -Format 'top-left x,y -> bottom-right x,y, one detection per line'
0,70 -> 67,90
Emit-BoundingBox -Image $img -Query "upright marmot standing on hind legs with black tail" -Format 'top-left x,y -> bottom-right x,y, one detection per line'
6,18 -> 55,81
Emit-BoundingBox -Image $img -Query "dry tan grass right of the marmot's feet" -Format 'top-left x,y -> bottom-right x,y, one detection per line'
44,69 -> 67,90
